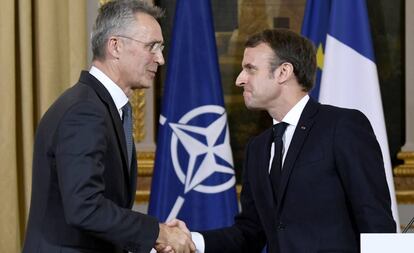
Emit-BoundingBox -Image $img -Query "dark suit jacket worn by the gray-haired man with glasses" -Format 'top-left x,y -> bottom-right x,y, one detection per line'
23,71 -> 159,253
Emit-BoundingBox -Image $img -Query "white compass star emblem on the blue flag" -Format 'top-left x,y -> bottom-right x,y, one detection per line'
159,105 -> 236,220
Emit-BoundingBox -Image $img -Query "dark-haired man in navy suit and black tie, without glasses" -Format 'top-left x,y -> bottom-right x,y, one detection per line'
169,30 -> 396,253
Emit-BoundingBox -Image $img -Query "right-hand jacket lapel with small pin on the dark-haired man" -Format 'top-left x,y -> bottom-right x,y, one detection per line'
277,98 -> 319,208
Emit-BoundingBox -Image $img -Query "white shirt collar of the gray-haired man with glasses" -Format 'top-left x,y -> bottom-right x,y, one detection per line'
89,66 -> 128,111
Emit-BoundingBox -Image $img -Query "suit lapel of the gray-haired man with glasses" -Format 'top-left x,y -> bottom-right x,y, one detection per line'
79,71 -> 130,182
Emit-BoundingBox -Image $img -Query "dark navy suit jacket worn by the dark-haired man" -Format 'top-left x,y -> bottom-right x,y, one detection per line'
202,99 -> 396,253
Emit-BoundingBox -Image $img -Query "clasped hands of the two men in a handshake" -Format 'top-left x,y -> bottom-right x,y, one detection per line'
155,219 -> 196,253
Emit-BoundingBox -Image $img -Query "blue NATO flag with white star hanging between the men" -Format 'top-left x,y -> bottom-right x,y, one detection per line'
148,0 -> 238,230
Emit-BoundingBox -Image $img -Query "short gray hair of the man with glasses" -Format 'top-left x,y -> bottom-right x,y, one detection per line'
91,0 -> 164,60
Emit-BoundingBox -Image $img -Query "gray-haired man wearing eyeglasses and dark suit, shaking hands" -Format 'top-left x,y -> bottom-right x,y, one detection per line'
23,0 -> 195,253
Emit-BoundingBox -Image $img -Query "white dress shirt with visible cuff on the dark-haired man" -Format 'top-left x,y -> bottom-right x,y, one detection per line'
191,95 -> 309,253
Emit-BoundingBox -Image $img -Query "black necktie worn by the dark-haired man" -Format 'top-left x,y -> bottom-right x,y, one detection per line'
270,122 -> 288,201
